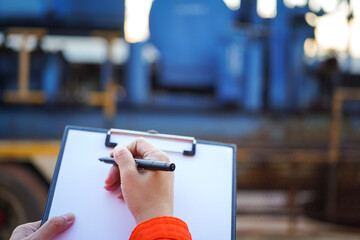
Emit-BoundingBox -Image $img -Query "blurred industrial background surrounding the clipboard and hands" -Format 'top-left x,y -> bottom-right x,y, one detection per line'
0,0 -> 360,240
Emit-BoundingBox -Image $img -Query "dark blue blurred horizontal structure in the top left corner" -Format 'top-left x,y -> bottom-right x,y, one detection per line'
0,0 -> 125,31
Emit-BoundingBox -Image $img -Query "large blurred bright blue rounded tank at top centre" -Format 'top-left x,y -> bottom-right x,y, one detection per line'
150,0 -> 231,89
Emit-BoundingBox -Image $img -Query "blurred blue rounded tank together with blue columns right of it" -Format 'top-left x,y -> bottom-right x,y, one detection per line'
130,0 -> 313,111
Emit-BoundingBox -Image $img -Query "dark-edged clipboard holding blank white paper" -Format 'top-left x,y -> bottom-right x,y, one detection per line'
42,126 -> 236,240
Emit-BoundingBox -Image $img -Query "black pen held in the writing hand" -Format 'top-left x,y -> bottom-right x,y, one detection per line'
99,157 -> 175,172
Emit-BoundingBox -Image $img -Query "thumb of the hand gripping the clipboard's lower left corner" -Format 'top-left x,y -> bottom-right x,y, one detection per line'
32,213 -> 75,239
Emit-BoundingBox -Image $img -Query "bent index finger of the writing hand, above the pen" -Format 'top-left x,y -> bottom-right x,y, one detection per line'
127,137 -> 169,162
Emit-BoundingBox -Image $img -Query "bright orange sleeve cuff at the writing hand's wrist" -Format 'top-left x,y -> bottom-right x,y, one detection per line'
129,217 -> 191,240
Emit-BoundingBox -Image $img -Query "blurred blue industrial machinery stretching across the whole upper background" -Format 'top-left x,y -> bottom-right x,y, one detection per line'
0,0 -> 322,139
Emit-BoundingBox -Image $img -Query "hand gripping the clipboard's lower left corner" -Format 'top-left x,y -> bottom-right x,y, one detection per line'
10,213 -> 75,240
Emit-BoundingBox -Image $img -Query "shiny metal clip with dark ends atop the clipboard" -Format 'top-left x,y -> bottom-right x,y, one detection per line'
105,128 -> 196,156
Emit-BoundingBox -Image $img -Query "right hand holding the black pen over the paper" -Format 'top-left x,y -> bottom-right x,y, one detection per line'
105,138 -> 174,224
